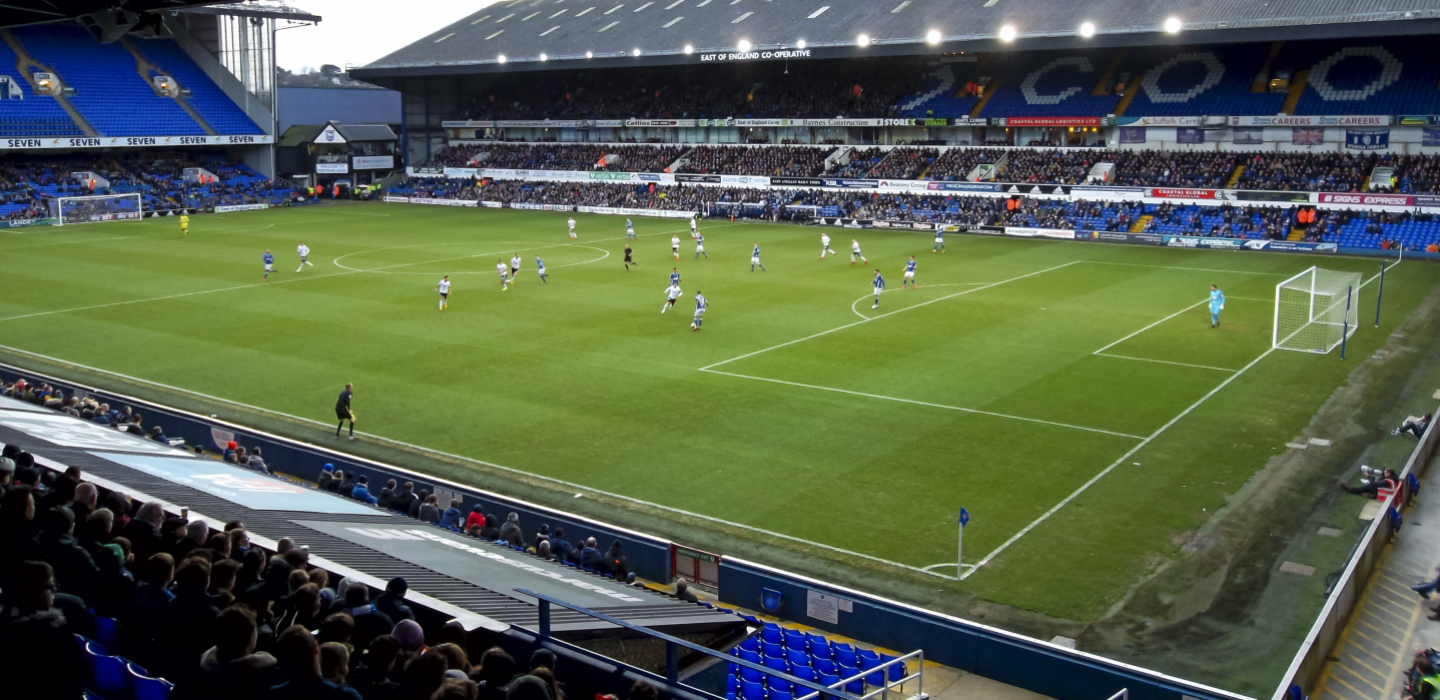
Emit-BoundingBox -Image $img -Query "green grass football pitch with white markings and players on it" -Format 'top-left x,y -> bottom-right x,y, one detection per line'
0,205 -> 1440,619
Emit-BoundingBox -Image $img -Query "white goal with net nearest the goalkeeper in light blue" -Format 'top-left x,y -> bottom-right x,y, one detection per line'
1272,268 -> 1361,354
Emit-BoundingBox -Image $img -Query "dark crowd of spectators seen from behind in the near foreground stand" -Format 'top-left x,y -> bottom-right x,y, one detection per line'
0,380 -> 693,700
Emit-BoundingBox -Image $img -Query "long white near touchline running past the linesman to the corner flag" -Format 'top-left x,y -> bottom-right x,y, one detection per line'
0,341 -> 953,579
